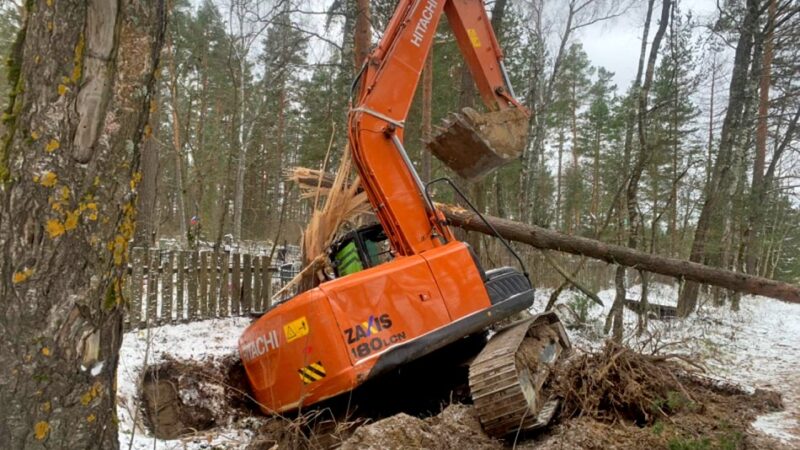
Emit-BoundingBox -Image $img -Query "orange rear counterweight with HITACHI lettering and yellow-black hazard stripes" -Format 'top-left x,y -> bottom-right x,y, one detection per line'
239,289 -> 355,413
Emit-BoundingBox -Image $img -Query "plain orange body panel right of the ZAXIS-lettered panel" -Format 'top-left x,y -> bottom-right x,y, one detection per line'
422,241 -> 491,320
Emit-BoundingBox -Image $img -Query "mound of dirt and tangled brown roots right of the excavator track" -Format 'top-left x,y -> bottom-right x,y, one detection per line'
544,342 -> 784,450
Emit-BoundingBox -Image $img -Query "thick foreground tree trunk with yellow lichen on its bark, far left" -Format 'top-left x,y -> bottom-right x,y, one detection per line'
0,0 -> 165,449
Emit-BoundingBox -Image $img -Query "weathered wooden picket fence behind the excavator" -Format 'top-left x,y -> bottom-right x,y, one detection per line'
125,248 -> 294,329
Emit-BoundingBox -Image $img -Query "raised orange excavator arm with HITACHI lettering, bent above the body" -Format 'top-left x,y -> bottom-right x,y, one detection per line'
348,0 -> 528,256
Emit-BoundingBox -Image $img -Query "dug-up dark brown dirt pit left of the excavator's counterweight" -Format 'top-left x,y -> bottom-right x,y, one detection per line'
141,355 -> 254,439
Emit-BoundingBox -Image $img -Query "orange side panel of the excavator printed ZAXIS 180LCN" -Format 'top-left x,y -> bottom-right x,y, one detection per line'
320,256 -> 450,376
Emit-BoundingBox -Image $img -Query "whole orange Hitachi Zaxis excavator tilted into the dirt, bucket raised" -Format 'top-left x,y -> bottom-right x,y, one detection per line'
239,0 -> 570,437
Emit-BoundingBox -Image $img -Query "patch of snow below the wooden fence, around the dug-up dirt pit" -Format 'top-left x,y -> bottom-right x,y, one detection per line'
117,317 -> 251,450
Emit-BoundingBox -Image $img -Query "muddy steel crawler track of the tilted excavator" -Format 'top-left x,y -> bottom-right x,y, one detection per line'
469,313 -> 570,437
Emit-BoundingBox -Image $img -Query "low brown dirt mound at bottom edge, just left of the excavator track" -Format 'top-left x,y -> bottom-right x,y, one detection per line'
342,405 -> 503,450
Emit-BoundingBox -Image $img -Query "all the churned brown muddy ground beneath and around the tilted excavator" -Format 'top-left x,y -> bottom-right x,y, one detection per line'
140,345 -> 789,450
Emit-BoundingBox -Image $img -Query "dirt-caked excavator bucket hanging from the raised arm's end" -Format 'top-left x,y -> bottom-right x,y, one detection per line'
427,108 -> 528,180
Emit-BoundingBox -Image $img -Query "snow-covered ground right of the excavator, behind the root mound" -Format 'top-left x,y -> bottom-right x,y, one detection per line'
533,284 -> 800,445
